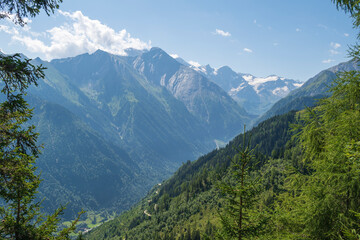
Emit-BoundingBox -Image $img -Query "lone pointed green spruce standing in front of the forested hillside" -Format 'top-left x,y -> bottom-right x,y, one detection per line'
217,127 -> 265,240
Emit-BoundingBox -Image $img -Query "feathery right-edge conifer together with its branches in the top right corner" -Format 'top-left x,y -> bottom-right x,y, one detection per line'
278,0 -> 360,239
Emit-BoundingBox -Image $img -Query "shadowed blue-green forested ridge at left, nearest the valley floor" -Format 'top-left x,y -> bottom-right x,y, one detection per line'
29,97 -> 151,219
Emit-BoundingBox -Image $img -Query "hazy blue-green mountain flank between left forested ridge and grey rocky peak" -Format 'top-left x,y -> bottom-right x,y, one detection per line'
51,51 -> 213,171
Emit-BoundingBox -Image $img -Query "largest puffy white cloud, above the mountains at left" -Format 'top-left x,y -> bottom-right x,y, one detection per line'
2,11 -> 151,60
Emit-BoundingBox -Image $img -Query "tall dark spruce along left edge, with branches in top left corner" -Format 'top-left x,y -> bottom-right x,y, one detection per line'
0,0 -> 82,240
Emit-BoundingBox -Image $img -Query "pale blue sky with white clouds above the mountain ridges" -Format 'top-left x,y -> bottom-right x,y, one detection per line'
0,0 -> 356,81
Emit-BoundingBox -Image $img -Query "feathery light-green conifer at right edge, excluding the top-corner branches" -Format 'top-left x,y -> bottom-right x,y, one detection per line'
293,71 -> 360,239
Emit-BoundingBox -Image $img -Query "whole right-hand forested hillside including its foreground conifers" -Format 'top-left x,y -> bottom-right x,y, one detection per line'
86,1 -> 360,239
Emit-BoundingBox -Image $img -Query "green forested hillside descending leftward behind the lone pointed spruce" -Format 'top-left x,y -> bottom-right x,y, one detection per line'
86,112 -> 296,239
